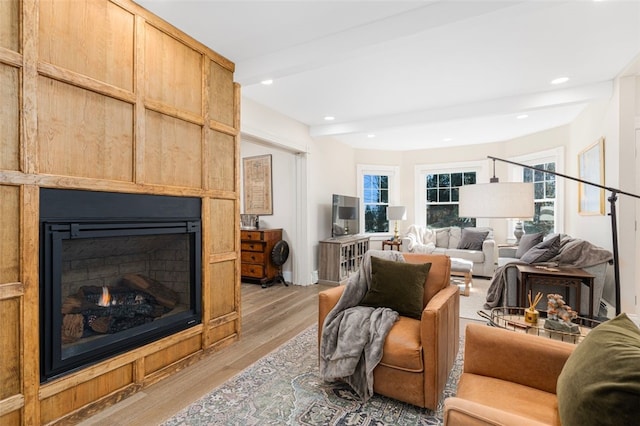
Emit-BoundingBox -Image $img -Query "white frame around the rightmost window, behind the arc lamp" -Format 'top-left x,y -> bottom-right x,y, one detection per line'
507,147 -> 565,242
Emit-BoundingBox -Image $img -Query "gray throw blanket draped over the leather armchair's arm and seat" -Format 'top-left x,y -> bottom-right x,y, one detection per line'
320,250 -> 404,401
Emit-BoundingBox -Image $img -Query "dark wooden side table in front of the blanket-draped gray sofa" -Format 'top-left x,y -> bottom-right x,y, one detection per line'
516,265 -> 595,318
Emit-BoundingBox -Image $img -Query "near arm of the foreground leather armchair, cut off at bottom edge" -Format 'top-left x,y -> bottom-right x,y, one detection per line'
444,397 -> 544,426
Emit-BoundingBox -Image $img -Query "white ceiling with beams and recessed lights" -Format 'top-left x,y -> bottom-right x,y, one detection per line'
137,0 -> 640,150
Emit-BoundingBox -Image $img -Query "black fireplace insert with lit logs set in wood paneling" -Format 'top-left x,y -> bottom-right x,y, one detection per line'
40,188 -> 202,382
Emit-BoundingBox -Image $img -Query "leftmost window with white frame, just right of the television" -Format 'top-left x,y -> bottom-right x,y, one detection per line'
358,165 -> 399,234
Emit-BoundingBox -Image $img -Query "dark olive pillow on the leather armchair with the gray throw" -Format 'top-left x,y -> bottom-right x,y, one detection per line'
360,256 -> 431,319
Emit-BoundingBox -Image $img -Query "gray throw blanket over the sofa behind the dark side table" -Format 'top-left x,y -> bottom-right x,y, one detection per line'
484,234 -> 613,309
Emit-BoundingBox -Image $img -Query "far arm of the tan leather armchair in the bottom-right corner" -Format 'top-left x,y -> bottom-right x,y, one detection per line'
464,324 -> 575,393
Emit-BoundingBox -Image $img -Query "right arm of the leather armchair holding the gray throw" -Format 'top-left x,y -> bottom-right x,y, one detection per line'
420,285 -> 460,407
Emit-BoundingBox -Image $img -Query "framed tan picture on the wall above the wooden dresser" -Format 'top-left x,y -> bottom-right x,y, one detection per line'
242,154 -> 273,215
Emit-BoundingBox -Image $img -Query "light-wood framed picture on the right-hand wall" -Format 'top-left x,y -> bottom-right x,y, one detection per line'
578,138 -> 604,215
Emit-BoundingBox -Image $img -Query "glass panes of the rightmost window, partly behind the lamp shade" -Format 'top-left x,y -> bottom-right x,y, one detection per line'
522,162 -> 556,235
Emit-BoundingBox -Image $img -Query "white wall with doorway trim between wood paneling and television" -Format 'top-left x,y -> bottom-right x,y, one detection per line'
240,98 -> 356,285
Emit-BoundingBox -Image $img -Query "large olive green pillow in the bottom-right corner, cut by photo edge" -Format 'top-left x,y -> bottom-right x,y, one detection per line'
556,313 -> 640,426
